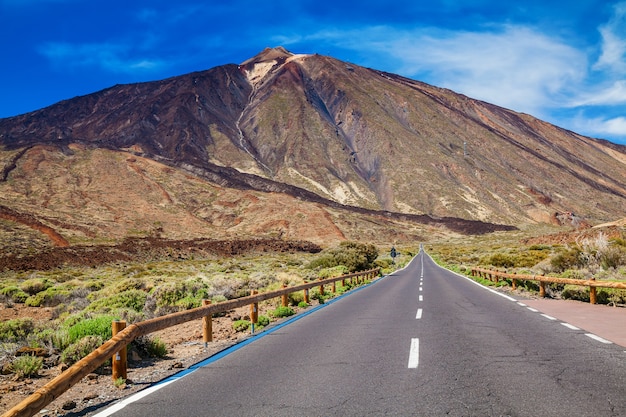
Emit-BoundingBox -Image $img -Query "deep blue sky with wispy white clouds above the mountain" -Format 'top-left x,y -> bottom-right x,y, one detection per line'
0,0 -> 626,144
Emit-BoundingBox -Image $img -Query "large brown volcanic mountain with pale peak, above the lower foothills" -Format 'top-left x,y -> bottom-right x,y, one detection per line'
0,47 -> 626,247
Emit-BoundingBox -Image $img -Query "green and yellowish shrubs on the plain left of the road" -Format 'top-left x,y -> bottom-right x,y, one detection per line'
0,242 -> 410,377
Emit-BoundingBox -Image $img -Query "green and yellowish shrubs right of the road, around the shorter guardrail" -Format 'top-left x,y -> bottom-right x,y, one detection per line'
426,230 -> 626,306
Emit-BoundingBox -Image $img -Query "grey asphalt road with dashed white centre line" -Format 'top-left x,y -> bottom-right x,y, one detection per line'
99,252 -> 626,417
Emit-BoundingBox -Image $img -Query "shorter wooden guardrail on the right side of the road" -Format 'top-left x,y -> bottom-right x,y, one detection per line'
471,268 -> 626,304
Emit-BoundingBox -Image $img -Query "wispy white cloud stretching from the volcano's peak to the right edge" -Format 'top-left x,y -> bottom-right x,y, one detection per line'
286,6 -> 626,138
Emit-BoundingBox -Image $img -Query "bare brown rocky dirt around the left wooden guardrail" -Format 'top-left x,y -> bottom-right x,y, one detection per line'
0,303 -> 312,417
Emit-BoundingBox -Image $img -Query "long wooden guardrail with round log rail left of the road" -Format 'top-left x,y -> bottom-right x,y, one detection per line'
2,268 -> 380,417
